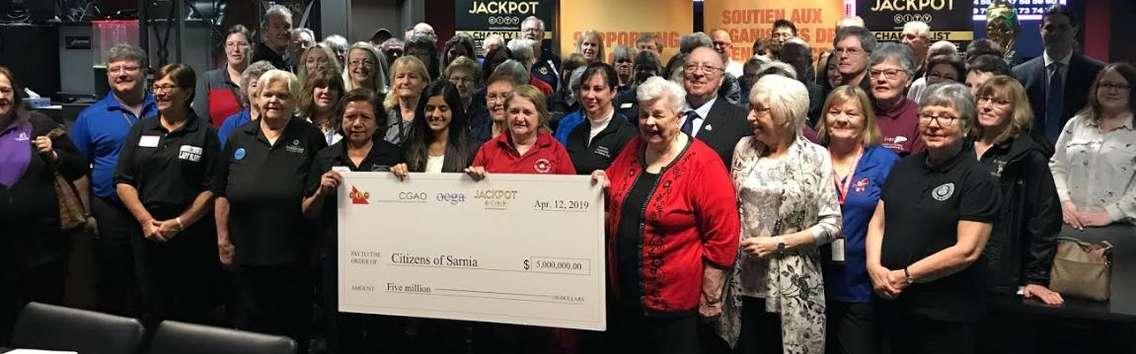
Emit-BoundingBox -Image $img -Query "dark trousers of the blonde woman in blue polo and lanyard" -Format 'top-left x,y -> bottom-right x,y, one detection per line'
825,301 -> 879,354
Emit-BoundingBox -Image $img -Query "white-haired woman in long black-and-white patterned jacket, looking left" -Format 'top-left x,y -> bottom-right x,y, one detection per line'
718,75 -> 841,353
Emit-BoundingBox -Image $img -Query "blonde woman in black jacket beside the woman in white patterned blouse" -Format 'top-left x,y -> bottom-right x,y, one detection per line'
970,75 -> 1064,353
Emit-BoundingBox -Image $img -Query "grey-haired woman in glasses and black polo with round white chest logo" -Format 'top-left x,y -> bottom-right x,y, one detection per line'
866,83 -> 1000,353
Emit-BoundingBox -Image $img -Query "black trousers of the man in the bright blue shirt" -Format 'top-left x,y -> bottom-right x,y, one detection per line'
91,197 -> 141,317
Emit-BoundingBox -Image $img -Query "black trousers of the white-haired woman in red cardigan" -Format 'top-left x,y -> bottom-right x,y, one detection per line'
608,310 -> 702,354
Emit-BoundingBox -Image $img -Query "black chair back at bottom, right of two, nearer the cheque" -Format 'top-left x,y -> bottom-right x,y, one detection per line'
145,321 -> 296,354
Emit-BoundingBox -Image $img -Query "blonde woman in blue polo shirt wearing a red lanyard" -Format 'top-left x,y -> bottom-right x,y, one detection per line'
817,85 -> 900,354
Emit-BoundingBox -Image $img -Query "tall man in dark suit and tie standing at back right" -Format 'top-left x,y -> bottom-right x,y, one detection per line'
1013,5 -> 1104,148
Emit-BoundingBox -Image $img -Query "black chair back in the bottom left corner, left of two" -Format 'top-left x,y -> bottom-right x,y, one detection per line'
11,303 -> 144,354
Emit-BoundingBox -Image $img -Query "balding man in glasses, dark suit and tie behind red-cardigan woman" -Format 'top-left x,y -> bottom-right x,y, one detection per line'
680,47 -> 753,169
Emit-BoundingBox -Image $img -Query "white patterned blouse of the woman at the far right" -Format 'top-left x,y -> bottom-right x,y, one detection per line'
1050,113 -> 1136,222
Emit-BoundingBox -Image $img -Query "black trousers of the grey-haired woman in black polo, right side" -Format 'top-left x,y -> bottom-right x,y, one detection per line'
877,302 -> 976,354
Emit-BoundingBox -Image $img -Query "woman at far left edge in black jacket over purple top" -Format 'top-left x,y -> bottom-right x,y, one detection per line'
0,66 -> 87,346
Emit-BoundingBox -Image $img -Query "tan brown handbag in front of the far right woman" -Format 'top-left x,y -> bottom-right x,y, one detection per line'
1050,236 -> 1112,301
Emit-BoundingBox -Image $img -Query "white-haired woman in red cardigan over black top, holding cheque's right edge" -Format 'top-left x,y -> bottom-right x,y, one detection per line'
592,77 -> 741,354
